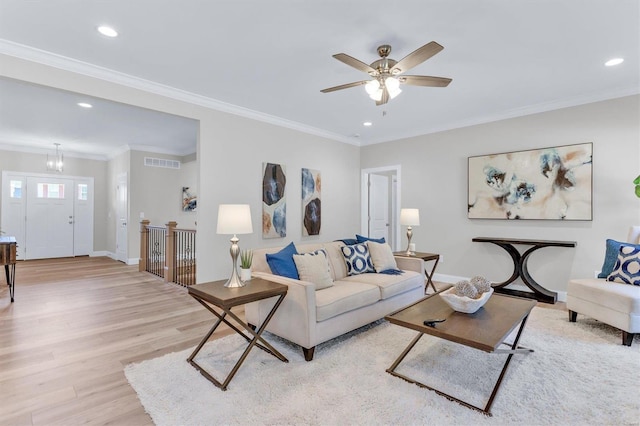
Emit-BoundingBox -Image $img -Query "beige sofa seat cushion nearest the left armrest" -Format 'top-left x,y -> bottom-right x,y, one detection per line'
316,281 -> 380,322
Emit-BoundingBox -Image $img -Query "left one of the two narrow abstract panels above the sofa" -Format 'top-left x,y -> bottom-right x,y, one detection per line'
262,163 -> 287,238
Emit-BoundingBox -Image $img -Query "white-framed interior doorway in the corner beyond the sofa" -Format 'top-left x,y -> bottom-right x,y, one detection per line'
360,165 -> 400,250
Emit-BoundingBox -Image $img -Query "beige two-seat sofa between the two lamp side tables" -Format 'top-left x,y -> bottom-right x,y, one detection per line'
245,242 -> 425,361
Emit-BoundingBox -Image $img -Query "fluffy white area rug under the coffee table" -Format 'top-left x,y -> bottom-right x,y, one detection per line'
125,308 -> 640,425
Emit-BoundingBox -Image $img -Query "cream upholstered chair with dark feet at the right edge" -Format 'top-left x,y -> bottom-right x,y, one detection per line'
567,226 -> 640,346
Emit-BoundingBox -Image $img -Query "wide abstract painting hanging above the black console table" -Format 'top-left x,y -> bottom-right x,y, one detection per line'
468,143 -> 593,220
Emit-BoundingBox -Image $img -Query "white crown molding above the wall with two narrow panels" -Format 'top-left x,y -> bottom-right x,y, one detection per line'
0,39 -> 361,146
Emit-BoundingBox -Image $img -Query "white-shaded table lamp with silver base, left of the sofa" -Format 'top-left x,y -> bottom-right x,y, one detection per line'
216,204 -> 253,287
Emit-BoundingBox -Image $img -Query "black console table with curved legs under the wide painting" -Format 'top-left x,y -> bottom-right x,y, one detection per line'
471,237 -> 577,303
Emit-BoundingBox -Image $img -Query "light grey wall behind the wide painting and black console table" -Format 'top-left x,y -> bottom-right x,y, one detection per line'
361,96 -> 640,291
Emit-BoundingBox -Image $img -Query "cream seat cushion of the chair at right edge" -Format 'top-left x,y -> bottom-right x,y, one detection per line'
567,278 -> 640,315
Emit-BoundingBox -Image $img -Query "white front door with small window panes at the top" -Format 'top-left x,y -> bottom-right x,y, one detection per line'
25,176 -> 74,259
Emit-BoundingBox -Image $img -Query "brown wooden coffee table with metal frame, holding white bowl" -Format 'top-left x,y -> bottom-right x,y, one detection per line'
385,293 -> 536,416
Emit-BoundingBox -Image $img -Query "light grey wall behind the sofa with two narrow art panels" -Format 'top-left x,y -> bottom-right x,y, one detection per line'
0,55 -> 360,282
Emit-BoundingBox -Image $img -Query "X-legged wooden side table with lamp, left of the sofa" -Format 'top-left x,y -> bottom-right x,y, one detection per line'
187,278 -> 289,390
